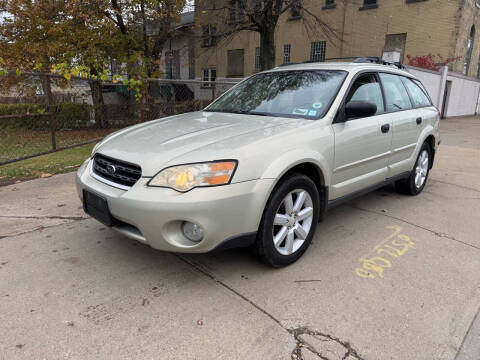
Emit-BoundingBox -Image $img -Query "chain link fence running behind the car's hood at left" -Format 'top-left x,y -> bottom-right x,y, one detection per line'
0,72 -> 240,165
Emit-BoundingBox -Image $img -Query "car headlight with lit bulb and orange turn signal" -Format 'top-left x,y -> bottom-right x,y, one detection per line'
148,160 -> 237,192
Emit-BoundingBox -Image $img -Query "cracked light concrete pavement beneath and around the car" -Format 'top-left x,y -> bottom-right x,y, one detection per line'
0,118 -> 480,360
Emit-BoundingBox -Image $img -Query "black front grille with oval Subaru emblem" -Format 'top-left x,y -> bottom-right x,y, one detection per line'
93,154 -> 142,187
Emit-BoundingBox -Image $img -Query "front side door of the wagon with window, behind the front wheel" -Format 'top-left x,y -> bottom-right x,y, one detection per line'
329,73 -> 392,200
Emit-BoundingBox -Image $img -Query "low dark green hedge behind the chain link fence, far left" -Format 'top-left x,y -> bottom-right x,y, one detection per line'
0,103 -> 91,130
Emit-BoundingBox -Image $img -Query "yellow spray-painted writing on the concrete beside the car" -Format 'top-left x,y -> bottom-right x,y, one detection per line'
355,226 -> 415,279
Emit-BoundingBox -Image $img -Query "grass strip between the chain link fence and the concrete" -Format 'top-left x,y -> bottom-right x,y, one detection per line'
0,144 -> 95,185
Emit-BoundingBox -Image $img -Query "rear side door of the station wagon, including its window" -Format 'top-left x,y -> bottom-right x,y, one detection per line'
380,73 -> 422,177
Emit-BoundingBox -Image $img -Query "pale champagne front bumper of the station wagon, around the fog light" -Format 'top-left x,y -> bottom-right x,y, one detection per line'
76,161 -> 274,253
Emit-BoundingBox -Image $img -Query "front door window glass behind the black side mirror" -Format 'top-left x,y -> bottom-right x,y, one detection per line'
347,74 -> 385,115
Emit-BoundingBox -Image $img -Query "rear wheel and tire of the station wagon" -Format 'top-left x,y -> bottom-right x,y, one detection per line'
395,143 -> 432,196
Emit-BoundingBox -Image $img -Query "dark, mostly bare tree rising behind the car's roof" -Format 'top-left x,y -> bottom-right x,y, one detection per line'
195,0 -> 340,70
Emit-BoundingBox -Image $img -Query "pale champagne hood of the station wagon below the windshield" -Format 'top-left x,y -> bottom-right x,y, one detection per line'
96,112 -> 305,176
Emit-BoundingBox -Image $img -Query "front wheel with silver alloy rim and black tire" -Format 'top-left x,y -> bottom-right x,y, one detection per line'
254,173 -> 320,268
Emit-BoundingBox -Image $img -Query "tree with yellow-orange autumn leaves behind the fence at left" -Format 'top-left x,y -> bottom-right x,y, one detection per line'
0,0 -> 185,122
